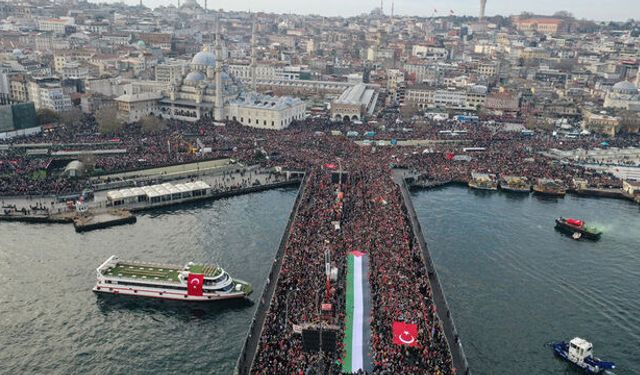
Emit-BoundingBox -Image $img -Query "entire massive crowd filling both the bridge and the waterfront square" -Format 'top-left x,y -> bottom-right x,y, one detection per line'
0,111 -> 640,375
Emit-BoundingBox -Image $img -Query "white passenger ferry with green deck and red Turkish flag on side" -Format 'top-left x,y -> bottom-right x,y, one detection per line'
93,255 -> 253,302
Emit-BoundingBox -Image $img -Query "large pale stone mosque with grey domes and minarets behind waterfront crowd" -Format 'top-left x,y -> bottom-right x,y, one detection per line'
115,24 -> 306,130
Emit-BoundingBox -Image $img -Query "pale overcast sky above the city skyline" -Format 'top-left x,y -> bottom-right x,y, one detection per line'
99,0 -> 640,21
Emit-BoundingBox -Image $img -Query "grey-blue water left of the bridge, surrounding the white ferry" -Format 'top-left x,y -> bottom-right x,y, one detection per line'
0,189 -> 297,375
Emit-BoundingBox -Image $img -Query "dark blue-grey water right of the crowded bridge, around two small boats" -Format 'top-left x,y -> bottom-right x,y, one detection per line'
413,187 -> 640,375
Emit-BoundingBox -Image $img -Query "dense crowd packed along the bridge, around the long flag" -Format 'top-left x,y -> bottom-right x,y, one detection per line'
252,137 -> 455,374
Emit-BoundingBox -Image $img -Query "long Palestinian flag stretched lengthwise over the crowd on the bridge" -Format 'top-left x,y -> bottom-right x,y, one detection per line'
342,251 -> 373,373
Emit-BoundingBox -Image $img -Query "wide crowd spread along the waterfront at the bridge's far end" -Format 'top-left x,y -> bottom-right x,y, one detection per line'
0,116 -> 640,196
